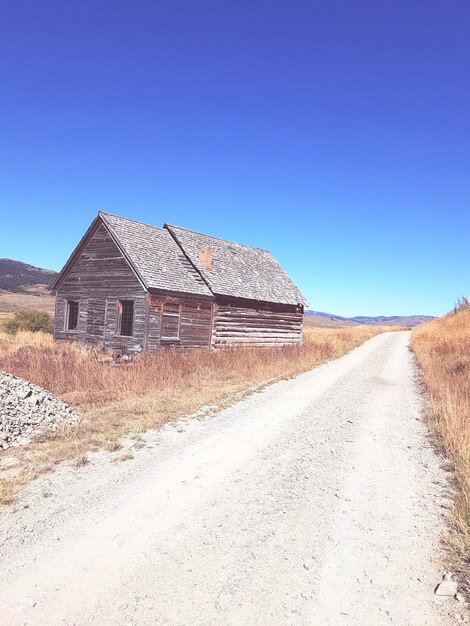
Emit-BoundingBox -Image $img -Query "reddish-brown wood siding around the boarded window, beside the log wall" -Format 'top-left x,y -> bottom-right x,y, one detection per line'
147,294 -> 212,352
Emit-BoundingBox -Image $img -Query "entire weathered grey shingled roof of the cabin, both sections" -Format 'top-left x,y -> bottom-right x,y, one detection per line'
54,211 -> 307,305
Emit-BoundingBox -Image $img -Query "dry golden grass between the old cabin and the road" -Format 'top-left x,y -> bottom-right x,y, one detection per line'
0,326 -> 396,502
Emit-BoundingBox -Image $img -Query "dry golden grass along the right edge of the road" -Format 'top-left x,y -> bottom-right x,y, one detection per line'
411,300 -> 470,586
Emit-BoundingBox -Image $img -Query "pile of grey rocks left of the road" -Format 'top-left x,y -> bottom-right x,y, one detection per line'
0,371 -> 79,450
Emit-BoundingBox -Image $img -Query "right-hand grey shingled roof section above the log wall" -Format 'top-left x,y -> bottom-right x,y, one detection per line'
165,224 -> 307,305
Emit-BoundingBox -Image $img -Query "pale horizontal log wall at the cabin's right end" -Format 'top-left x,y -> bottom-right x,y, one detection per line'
212,299 -> 303,348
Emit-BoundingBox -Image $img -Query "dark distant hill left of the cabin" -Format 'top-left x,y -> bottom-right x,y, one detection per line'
0,259 -> 57,294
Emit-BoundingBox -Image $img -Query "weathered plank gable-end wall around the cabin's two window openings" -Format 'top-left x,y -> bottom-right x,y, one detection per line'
54,224 -> 147,352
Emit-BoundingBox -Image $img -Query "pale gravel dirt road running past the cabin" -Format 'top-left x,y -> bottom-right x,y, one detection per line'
0,333 -> 458,626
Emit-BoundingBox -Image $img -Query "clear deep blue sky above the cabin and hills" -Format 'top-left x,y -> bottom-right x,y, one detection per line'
0,0 -> 470,315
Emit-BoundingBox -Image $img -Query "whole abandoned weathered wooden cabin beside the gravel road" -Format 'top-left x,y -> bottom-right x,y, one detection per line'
53,212 -> 306,353
